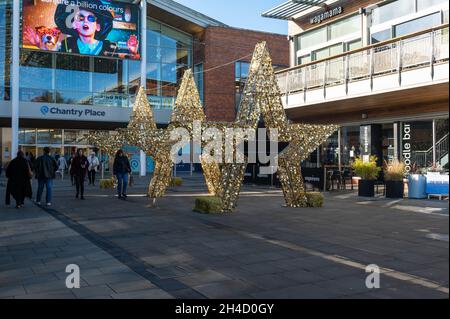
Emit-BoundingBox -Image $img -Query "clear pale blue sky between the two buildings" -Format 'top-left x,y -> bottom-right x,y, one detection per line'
175,0 -> 287,34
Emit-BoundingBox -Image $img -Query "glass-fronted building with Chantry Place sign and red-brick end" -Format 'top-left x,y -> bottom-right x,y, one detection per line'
0,0 -> 289,171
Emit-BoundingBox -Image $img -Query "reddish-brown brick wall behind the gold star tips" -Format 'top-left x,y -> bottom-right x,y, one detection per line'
200,27 -> 289,122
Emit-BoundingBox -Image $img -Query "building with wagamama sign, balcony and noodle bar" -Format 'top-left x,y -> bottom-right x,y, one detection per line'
263,0 -> 449,175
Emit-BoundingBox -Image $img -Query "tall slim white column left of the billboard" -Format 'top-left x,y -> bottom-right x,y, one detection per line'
10,0 -> 20,159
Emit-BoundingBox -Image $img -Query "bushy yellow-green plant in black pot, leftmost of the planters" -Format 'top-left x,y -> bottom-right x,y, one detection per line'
352,156 -> 381,197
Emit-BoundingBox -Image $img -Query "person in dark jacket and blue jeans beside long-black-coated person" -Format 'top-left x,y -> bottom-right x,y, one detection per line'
34,147 -> 58,206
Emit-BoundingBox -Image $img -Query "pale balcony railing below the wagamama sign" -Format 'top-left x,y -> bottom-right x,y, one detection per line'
276,24 -> 449,99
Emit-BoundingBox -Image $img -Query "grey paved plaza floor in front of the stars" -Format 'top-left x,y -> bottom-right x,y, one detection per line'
0,176 -> 449,299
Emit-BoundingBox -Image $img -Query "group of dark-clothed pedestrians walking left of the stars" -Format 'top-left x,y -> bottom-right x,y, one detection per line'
5,147 -> 131,208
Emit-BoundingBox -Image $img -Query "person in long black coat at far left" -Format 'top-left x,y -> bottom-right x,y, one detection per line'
6,151 -> 33,208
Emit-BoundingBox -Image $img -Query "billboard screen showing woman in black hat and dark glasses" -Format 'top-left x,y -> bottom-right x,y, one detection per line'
22,0 -> 140,60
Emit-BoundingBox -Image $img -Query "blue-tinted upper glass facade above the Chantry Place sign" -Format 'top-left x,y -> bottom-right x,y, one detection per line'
0,12 -> 193,109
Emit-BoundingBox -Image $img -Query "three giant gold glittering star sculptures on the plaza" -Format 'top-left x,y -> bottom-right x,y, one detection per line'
88,42 -> 338,212
